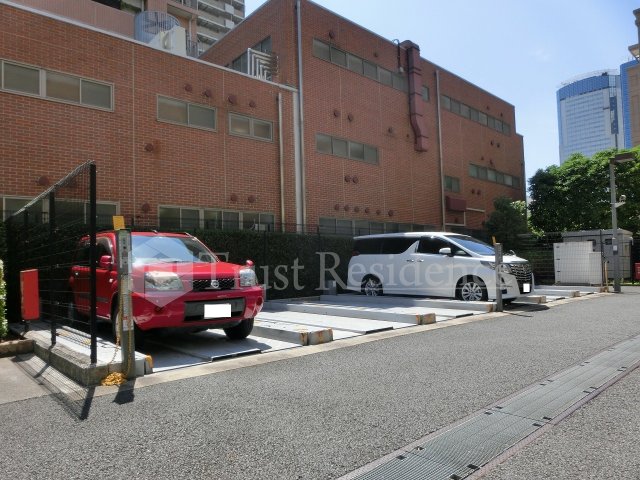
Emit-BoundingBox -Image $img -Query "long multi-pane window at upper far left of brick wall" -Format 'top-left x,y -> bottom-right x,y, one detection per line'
0,60 -> 113,110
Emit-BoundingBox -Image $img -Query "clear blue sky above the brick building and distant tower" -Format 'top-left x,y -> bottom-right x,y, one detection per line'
245,0 -> 640,188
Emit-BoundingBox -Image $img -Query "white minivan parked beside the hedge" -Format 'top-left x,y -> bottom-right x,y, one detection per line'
347,232 -> 533,301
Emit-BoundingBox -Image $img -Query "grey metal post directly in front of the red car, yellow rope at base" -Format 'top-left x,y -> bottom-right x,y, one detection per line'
111,230 -> 135,378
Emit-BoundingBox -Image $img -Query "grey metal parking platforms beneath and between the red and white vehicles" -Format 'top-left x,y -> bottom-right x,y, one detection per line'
87,287 -> 612,374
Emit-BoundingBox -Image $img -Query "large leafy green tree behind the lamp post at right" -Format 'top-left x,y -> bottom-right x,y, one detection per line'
529,150 -> 640,232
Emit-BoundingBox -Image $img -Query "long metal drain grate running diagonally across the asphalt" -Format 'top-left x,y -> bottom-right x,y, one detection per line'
343,336 -> 640,480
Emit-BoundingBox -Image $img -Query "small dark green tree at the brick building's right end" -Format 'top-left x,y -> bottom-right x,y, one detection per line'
485,197 -> 527,251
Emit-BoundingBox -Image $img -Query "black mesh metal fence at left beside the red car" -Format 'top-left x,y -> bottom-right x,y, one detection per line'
4,162 -> 97,363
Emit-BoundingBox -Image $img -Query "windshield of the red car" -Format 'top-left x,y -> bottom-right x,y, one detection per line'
131,235 -> 217,265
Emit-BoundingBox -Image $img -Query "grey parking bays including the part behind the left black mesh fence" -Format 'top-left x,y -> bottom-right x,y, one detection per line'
13,286 -> 602,384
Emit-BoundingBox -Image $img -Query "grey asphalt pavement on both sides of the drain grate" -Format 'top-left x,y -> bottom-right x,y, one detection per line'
0,288 -> 640,479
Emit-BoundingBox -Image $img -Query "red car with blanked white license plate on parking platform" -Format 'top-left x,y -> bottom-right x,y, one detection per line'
69,232 -> 264,340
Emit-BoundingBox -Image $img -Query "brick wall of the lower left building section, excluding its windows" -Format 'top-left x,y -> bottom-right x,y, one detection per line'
0,5 -> 294,224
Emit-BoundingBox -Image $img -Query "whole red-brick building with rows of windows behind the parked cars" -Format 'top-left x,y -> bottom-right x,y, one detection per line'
0,0 -> 525,234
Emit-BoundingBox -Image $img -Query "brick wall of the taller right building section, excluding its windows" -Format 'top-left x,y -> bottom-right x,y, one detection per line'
203,0 -> 525,229
